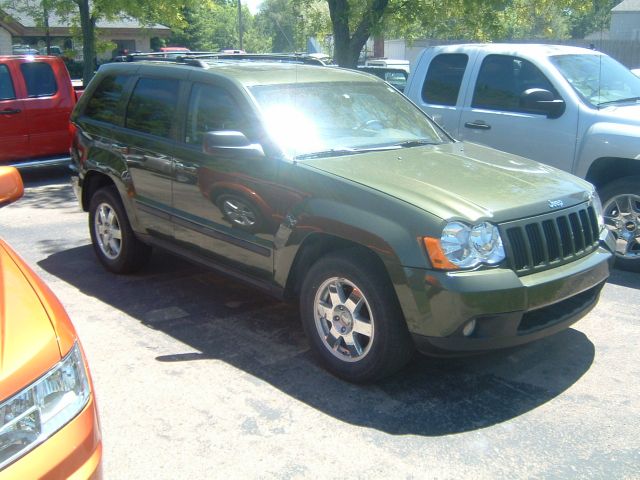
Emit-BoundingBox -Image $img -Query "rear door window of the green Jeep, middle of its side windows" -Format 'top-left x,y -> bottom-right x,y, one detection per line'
126,78 -> 179,137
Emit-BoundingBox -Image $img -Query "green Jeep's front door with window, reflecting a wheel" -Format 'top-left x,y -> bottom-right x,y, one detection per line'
172,83 -> 280,280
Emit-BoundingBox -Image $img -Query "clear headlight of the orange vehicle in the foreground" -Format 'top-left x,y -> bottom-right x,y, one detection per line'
0,343 -> 90,469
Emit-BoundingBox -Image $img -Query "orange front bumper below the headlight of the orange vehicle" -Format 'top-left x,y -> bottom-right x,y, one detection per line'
0,395 -> 102,480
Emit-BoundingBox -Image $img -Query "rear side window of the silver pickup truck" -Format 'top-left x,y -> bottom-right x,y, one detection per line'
422,53 -> 469,106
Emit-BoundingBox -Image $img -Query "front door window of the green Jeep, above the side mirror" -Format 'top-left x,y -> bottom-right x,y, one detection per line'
185,84 -> 247,145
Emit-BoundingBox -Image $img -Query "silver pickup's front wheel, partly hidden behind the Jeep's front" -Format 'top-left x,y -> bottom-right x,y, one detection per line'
599,177 -> 640,272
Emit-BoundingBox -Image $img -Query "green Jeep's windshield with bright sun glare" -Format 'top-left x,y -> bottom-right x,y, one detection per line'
250,82 -> 450,159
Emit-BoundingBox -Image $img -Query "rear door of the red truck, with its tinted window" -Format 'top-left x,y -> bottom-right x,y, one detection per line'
20,60 -> 73,158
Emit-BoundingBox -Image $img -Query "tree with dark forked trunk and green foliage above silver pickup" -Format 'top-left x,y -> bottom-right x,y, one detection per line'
327,0 -> 600,67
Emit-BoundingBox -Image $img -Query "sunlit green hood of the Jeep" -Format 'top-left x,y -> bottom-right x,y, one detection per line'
301,142 -> 593,223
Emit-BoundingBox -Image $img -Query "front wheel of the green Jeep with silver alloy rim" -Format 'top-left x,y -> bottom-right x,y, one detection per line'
300,254 -> 413,382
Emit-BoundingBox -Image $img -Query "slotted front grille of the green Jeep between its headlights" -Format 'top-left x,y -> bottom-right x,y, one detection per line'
500,205 -> 599,275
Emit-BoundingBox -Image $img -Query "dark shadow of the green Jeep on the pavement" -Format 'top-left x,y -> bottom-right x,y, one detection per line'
39,245 -> 595,436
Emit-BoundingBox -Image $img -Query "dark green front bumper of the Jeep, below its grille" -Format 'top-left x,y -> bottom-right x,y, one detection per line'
397,243 -> 614,355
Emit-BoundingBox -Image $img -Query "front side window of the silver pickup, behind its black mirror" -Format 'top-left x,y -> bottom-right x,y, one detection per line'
471,55 -> 558,113
